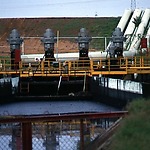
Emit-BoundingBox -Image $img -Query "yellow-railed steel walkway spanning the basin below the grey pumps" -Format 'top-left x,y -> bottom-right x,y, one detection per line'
0,56 -> 150,77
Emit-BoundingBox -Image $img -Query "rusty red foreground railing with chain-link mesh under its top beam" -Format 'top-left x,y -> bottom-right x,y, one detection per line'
0,111 -> 127,150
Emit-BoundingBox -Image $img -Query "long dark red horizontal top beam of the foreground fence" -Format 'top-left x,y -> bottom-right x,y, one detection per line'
0,111 -> 128,123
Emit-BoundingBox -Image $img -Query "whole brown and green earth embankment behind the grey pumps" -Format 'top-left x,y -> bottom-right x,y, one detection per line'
0,17 -> 120,56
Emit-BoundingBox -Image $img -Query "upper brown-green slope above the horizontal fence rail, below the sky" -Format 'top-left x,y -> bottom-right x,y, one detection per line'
0,17 -> 120,40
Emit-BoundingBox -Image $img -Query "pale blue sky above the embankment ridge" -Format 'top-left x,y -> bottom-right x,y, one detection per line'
0,0 -> 150,18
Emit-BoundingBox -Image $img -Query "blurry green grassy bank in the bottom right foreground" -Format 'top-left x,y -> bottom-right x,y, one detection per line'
109,99 -> 150,150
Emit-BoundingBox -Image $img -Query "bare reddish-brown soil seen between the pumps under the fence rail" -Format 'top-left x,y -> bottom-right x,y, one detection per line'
0,38 -> 78,56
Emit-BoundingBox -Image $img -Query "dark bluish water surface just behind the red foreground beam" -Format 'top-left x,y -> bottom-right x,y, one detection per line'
0,100 -> 117,115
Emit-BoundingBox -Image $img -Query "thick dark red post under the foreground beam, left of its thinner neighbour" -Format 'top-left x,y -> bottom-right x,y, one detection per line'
22,122 -> 32,150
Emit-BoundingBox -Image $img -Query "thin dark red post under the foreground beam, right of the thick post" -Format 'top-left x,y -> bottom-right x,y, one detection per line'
80,119 -> 84,150
